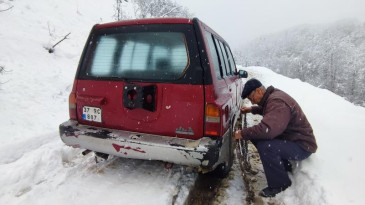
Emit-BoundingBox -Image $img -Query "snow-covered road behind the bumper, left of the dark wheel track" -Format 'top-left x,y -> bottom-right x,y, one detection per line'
0,132 -> 197,204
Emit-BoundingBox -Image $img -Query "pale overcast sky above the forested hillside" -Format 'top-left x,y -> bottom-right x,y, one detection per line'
176,0 -> 365,49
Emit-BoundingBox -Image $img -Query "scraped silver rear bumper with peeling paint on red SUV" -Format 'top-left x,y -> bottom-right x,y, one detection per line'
59,120 -> 224,170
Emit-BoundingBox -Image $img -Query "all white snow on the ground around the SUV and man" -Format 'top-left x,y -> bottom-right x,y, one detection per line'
0,0 -> 365,205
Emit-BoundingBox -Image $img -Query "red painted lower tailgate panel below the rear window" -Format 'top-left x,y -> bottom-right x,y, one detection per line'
76,80 -> 205,139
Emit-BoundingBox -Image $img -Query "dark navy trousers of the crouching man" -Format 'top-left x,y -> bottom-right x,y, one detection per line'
251,139 -> 311,188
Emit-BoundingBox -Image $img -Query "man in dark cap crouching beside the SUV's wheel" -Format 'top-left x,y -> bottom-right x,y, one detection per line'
234,79 -> 317,197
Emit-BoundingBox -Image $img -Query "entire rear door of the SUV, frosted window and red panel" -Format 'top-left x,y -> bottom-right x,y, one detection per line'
76,24 -> 204,139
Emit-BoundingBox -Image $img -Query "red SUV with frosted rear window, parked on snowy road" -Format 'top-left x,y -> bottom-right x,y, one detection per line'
60,18 -> 247,176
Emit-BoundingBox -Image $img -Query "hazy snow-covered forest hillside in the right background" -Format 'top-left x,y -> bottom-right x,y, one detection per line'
235,20 -> 365,106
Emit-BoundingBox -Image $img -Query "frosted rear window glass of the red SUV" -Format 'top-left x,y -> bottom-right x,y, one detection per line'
82,28 -> 189,80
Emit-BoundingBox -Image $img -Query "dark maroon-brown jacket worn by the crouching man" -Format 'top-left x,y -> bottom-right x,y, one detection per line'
242,86 -> 317,153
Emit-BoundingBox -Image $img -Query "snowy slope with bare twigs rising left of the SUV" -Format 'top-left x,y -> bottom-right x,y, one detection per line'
0,0 -> 113,144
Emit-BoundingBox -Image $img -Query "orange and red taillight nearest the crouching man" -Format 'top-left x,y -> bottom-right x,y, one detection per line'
204,104 -> 221,136
